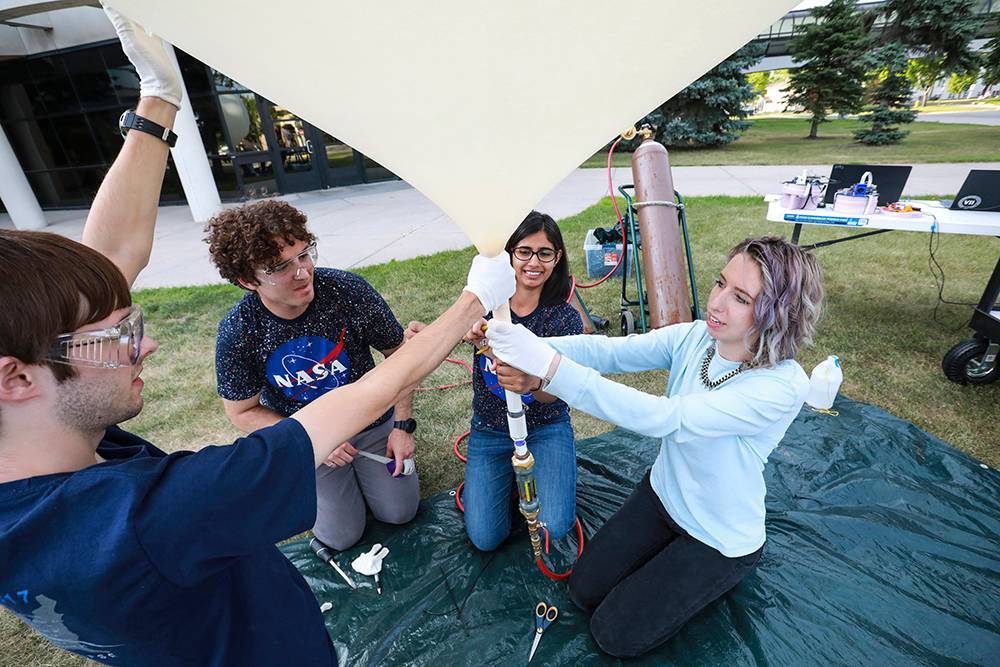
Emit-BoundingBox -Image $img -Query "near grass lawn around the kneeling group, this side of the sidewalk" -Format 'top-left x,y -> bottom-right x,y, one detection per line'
0,196 -> 1000,667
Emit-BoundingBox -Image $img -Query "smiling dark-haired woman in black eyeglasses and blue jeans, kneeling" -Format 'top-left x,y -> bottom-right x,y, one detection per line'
462,211 -> 583,551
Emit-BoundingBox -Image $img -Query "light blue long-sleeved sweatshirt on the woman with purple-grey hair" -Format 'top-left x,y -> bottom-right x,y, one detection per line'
545,320 -> 809,558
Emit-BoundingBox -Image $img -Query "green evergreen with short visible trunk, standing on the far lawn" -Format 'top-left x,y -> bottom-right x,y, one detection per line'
785,0 -> 867,139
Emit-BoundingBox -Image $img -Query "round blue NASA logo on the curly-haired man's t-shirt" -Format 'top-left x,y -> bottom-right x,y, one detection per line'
267,330 -> 351,403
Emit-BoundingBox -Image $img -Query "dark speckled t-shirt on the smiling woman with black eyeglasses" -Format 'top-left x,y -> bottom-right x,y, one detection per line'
472,303 -> 583,433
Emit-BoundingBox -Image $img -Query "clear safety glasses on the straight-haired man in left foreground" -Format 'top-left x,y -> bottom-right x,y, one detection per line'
48,305 -> 145,368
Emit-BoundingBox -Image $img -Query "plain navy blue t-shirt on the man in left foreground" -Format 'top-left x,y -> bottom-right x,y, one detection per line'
0,419 -> 337,667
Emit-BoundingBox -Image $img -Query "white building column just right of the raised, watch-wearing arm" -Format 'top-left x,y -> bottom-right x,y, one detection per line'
163,42 -> 222,222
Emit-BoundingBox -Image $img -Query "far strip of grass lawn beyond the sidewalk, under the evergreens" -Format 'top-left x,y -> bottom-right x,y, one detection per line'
582,118 -> 1000,167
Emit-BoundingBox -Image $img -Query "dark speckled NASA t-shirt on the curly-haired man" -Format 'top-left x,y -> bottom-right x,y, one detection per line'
215,268 -> 403,426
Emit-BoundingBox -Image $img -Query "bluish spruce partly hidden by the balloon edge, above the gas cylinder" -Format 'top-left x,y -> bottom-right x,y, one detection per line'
623,45 -> 763,149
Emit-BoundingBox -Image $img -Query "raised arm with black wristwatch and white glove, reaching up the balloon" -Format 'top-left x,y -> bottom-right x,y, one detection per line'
83,7 -> 181,286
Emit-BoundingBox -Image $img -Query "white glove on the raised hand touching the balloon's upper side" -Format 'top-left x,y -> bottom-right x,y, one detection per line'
104,5 -> 182,109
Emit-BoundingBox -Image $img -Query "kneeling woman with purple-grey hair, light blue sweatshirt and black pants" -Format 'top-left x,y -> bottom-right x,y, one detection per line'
488,237 -> 823,657
